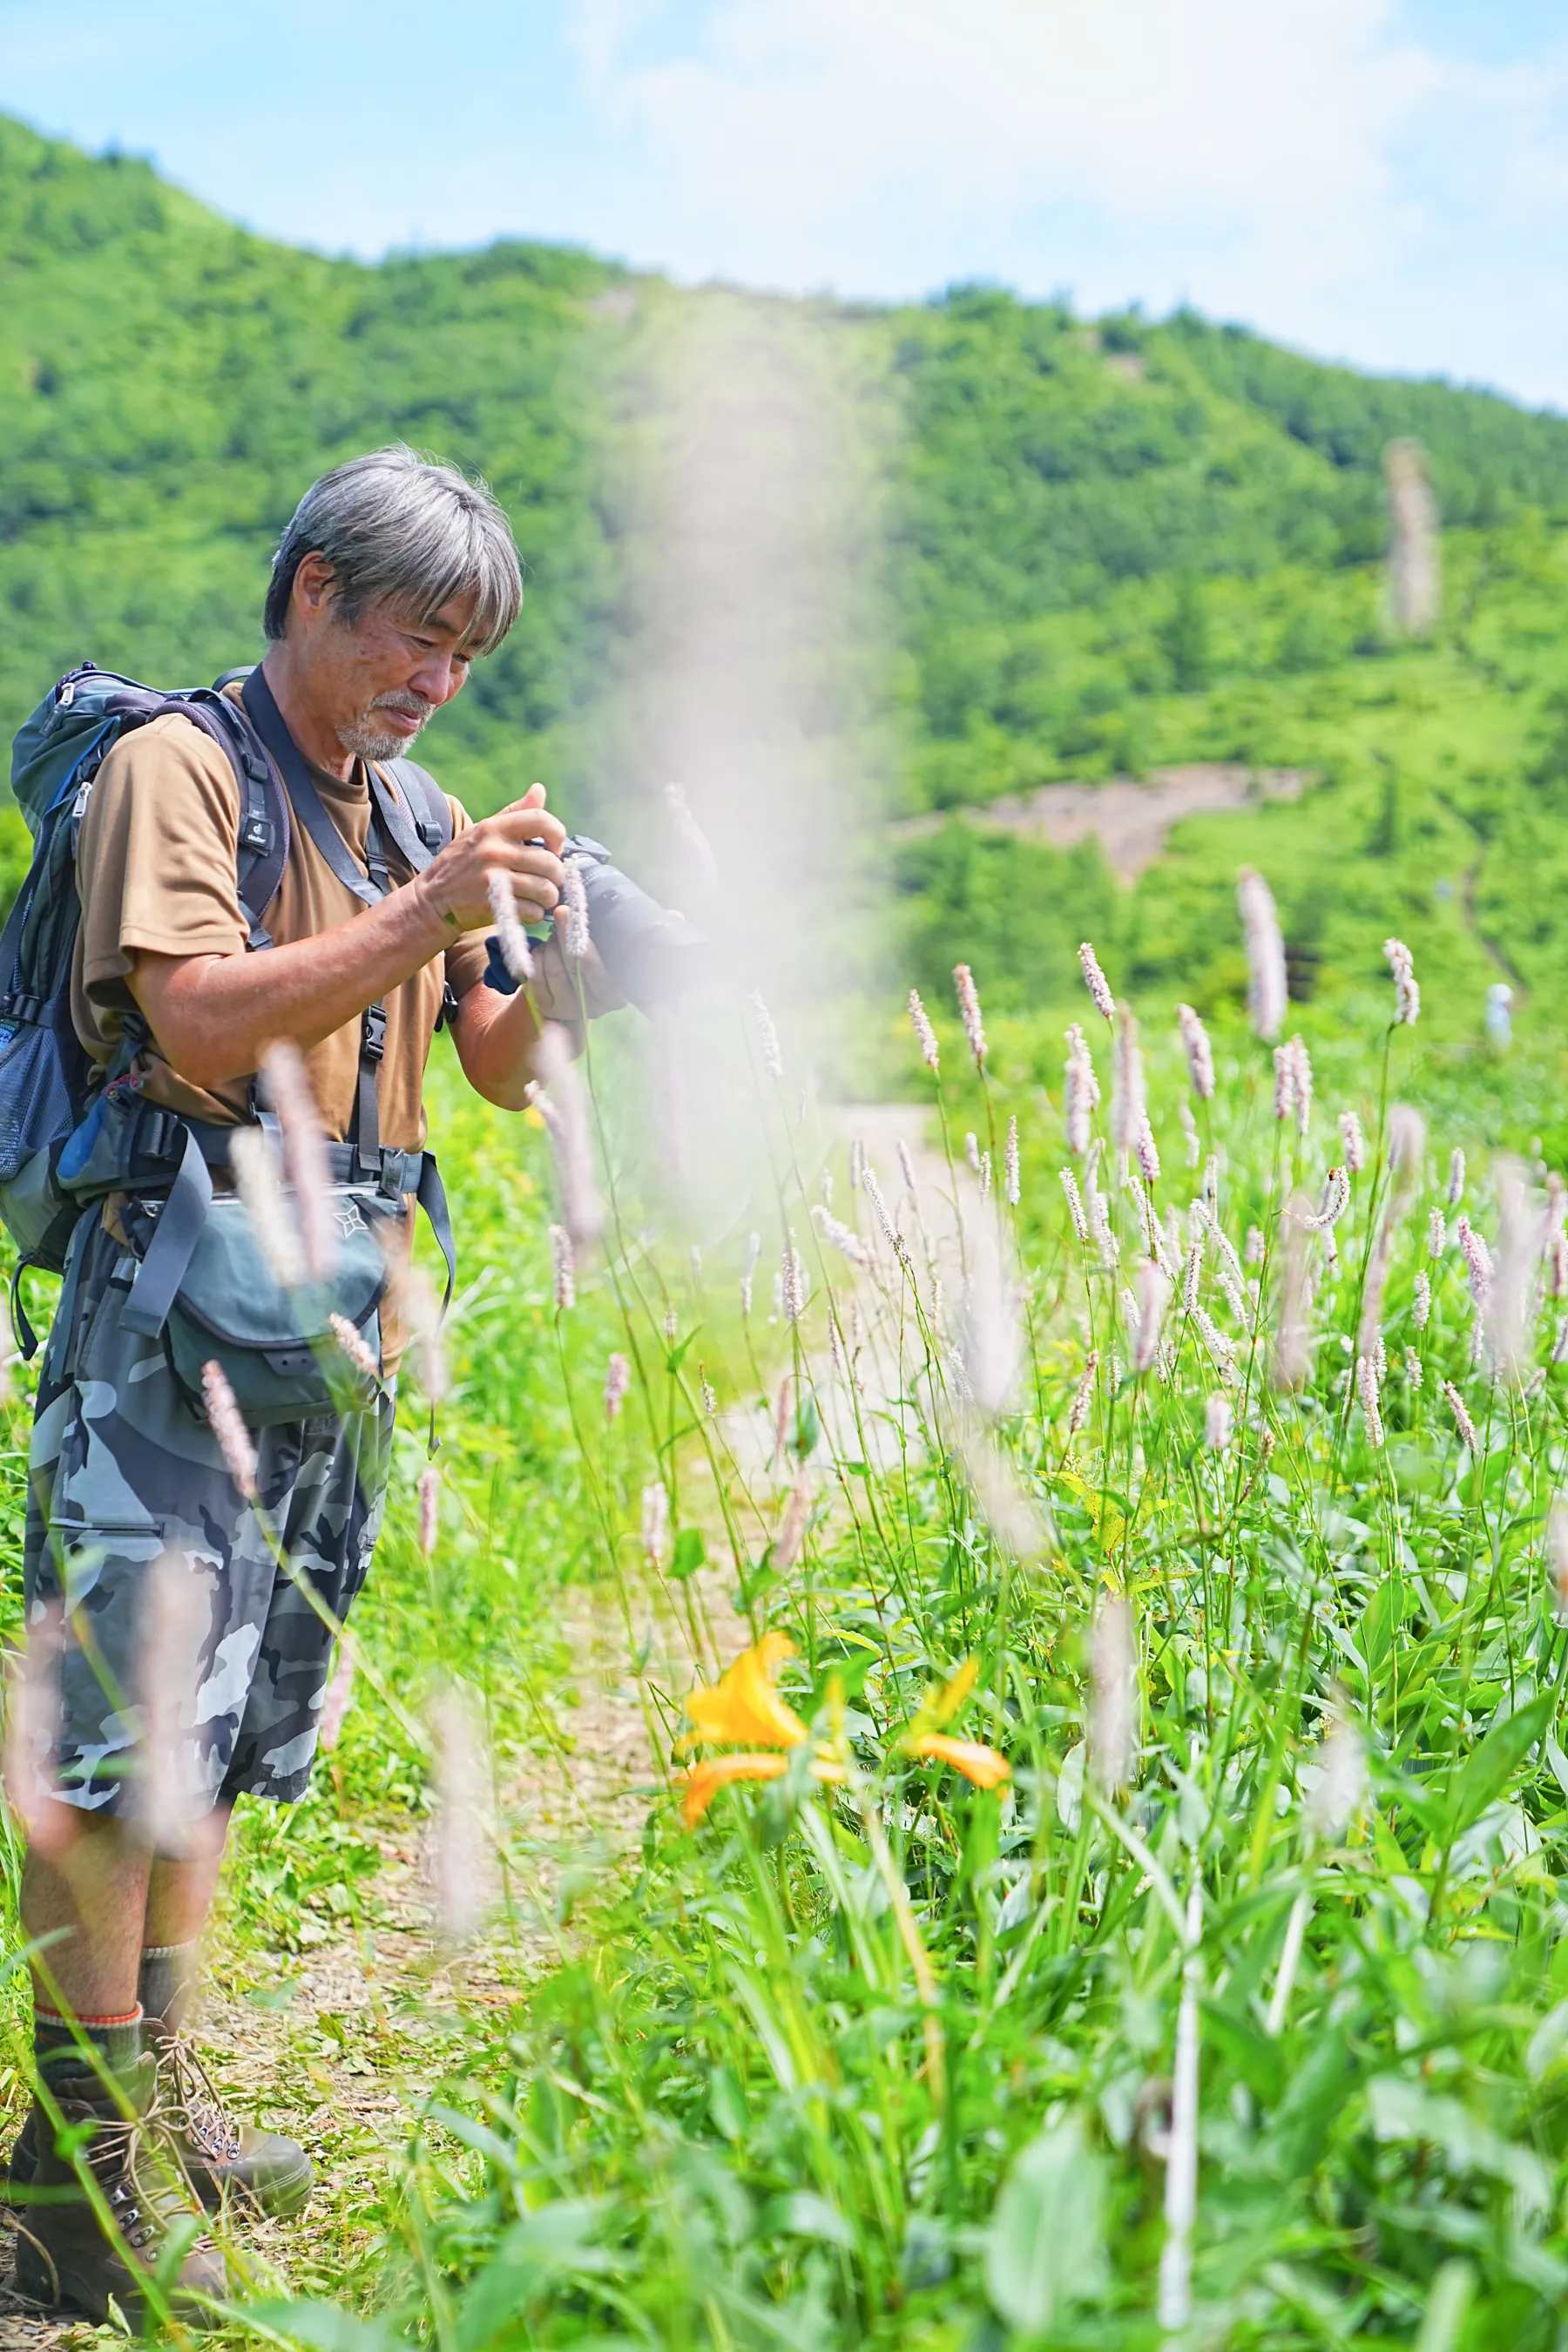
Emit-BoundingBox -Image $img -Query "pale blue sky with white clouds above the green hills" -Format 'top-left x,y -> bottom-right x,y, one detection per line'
0,0 -> 1568,409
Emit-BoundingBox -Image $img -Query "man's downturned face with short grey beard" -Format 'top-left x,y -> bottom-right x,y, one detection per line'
296,555 -> 475,760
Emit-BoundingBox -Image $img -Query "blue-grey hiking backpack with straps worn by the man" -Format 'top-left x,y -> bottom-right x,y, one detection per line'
0,663 -> 451,1357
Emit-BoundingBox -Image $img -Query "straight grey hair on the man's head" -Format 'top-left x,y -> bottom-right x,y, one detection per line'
261,443 -> 522,654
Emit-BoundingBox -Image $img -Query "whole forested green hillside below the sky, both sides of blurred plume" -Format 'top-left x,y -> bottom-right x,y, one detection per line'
0,120 -> 1568,1025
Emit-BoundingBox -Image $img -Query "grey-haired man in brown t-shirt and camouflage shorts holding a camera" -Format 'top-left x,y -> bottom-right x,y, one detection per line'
11,449 -> 618,2319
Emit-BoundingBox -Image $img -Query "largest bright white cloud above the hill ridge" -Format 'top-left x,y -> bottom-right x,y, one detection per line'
578,0 -> 1441,289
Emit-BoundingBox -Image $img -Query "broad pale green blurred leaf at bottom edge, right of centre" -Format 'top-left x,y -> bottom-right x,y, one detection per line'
985,2114 -> 1105,2335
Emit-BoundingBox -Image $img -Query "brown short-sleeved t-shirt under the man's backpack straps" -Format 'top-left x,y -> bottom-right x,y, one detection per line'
71,713 -> 484,1150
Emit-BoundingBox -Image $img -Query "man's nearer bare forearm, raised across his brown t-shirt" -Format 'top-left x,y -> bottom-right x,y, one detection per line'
129,884 -> 458,1086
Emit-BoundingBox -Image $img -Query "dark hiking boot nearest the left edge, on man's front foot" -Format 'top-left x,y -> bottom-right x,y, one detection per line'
11,2056 -> 228,2328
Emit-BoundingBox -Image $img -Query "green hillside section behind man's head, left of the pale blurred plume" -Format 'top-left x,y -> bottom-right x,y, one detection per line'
0,120 -> 616,797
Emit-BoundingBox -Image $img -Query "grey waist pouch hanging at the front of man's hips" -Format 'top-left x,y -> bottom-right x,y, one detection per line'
122,1190 -> 395,1430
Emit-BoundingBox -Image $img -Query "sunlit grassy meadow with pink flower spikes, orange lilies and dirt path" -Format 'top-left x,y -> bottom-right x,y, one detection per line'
10,926 -> 1568,2352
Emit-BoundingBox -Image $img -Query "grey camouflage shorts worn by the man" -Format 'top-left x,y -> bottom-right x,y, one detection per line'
24,1213 -> 393,1815
